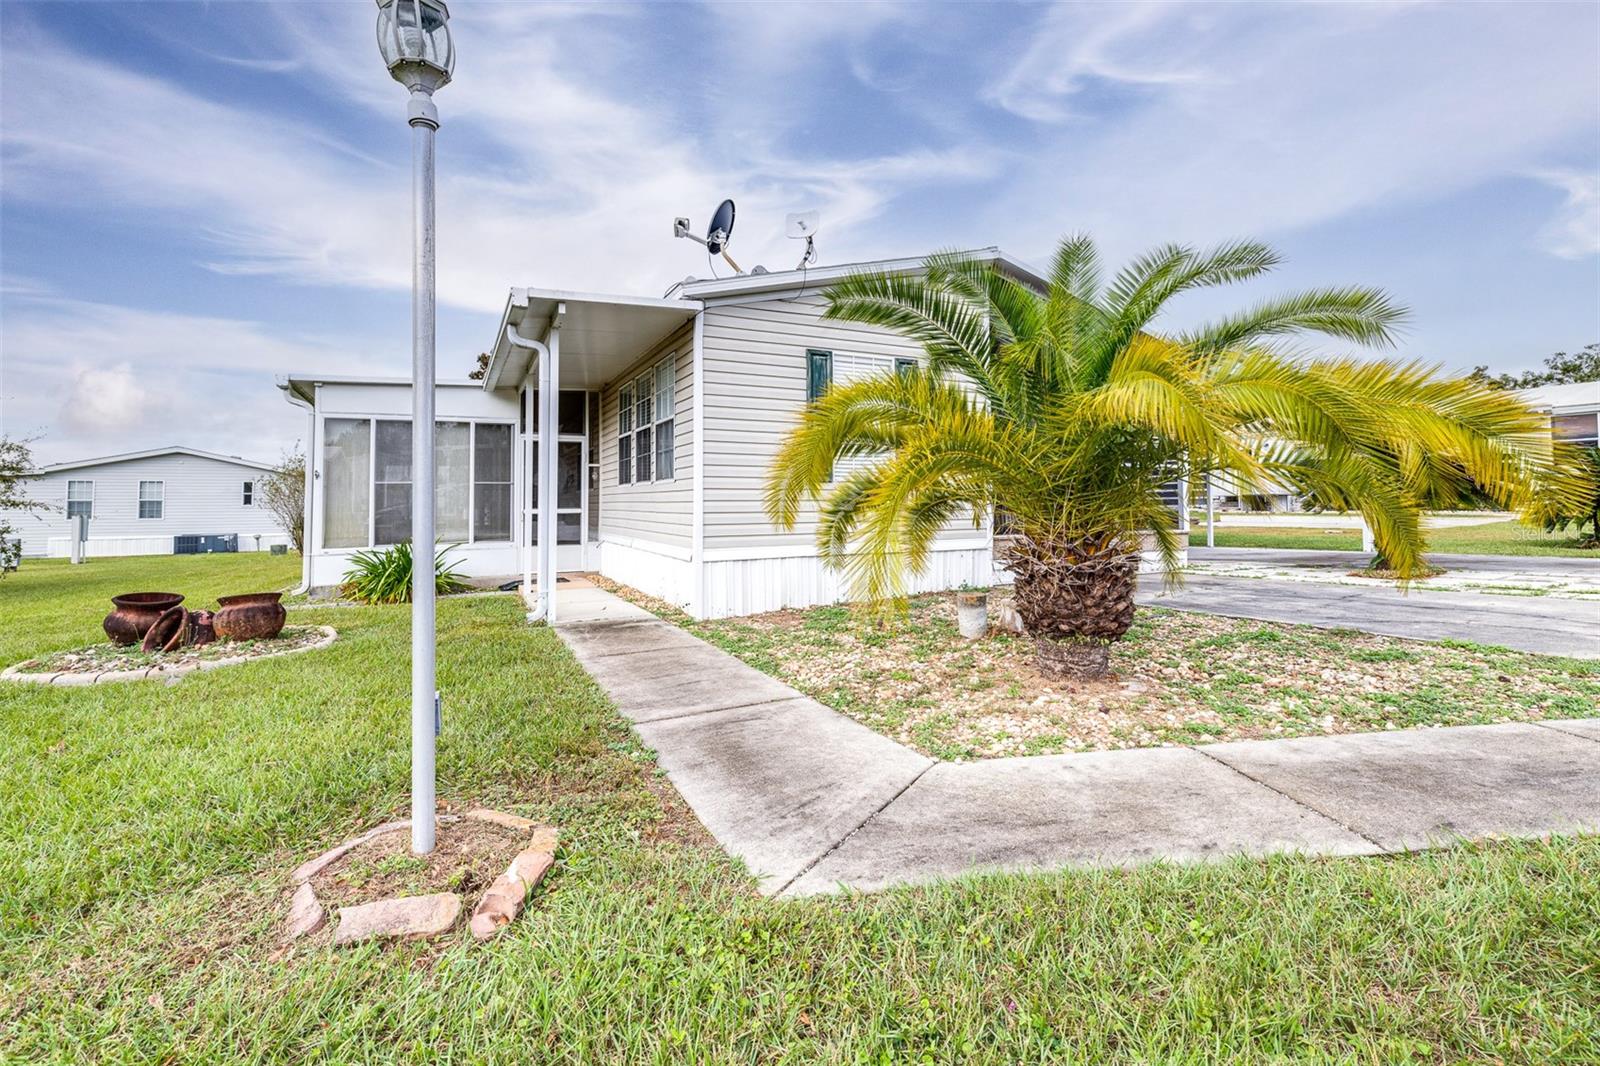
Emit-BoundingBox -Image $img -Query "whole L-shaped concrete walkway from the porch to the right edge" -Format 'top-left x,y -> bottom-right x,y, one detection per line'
557,589 -> 1600,896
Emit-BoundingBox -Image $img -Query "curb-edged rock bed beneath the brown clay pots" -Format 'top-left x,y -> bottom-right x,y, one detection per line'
0,626 -> 338,685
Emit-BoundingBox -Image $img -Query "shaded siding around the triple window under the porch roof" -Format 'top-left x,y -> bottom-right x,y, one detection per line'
590,327 -> 694,547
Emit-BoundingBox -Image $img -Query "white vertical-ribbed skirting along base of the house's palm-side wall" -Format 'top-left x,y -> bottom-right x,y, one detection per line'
696,547 -> 1010,618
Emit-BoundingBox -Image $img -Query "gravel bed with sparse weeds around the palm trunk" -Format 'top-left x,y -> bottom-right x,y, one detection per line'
680,595 -> 1600,759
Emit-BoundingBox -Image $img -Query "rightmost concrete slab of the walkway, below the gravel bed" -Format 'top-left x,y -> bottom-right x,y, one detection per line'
1205,723 -> 1600,850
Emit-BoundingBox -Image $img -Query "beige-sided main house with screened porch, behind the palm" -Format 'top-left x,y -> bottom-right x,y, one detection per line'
278,248 -> 1187,618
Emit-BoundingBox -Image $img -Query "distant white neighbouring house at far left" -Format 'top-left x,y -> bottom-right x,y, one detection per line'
8,447 -> 290,557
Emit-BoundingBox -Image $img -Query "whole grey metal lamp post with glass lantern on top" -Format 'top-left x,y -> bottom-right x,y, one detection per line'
378,0 -> 456,855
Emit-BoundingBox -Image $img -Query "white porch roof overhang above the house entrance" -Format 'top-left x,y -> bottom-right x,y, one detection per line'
483,288 -> 701,389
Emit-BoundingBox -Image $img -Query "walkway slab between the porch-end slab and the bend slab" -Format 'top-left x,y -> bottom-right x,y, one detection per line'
560,640 -> 795,722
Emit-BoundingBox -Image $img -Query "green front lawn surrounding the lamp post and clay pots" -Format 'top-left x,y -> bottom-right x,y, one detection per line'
0,555 -> 1600,1063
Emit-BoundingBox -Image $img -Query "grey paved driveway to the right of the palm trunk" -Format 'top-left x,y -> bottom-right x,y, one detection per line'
1139,573 -> 1600,659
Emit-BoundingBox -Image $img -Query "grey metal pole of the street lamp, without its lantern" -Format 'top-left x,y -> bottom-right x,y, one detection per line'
410,90 -> 438,855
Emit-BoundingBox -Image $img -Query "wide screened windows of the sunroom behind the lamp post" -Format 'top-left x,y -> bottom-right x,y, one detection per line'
322,418 -> 515,547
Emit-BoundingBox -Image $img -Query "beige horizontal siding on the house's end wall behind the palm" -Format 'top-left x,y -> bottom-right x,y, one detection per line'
702,295 -> 960,552
